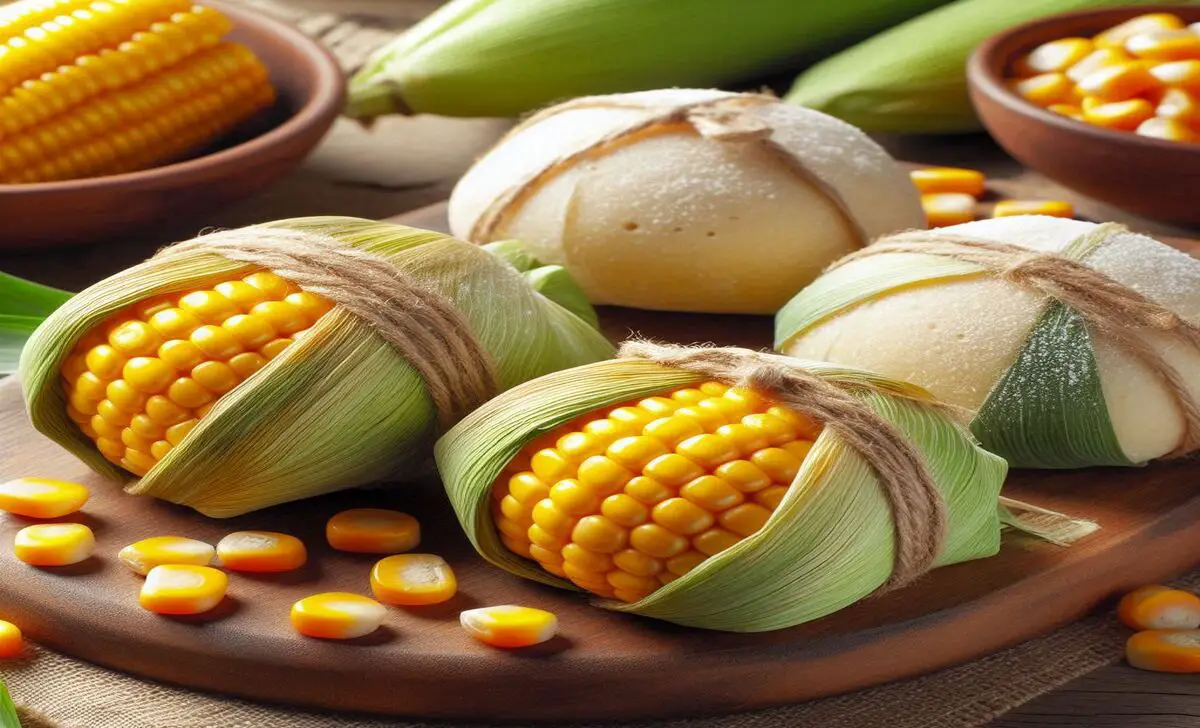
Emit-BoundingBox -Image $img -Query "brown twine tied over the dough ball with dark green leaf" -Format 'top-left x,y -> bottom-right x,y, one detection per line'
828,223 -> 1200,457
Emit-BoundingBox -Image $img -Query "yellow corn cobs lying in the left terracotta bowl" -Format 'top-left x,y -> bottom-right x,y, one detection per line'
0,0 -> 275,183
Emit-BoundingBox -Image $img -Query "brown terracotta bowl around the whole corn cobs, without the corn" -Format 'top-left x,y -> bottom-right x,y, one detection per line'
0,0 -> 346,248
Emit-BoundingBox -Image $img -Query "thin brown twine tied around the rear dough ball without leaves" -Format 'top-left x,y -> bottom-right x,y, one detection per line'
468,94 -> 870,246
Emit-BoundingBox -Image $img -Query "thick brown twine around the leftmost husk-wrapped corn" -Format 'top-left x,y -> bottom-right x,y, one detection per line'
155,227 -> 499,428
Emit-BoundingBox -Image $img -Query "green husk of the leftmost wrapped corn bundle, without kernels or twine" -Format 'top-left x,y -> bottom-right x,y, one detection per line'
19,217 -> 612,517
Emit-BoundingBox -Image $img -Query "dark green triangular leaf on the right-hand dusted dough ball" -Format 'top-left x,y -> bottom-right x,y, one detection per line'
971,302 -> 1134,468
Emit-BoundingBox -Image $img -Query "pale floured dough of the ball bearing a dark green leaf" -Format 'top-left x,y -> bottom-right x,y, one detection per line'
784,216 -> 1200,462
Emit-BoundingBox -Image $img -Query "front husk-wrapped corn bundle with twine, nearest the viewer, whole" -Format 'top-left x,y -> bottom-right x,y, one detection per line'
436,343 -> 1088,632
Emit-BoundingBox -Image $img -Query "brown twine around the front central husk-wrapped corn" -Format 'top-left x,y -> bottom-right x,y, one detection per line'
618,341 -> 947,591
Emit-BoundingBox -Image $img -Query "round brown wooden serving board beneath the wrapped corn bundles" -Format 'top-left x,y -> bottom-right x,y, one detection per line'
0,206 -> 1200,723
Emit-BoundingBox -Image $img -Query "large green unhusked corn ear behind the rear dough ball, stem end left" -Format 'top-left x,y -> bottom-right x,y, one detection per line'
347,0 -> 946,119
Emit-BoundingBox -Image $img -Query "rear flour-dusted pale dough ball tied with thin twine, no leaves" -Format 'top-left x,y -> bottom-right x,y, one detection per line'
450,89 -> 925,313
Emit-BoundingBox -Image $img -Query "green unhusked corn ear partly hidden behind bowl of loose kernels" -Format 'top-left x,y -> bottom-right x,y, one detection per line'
785,0 -> 1180,133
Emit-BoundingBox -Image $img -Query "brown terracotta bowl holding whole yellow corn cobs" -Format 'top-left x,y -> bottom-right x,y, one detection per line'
0,0 -> 344,247
